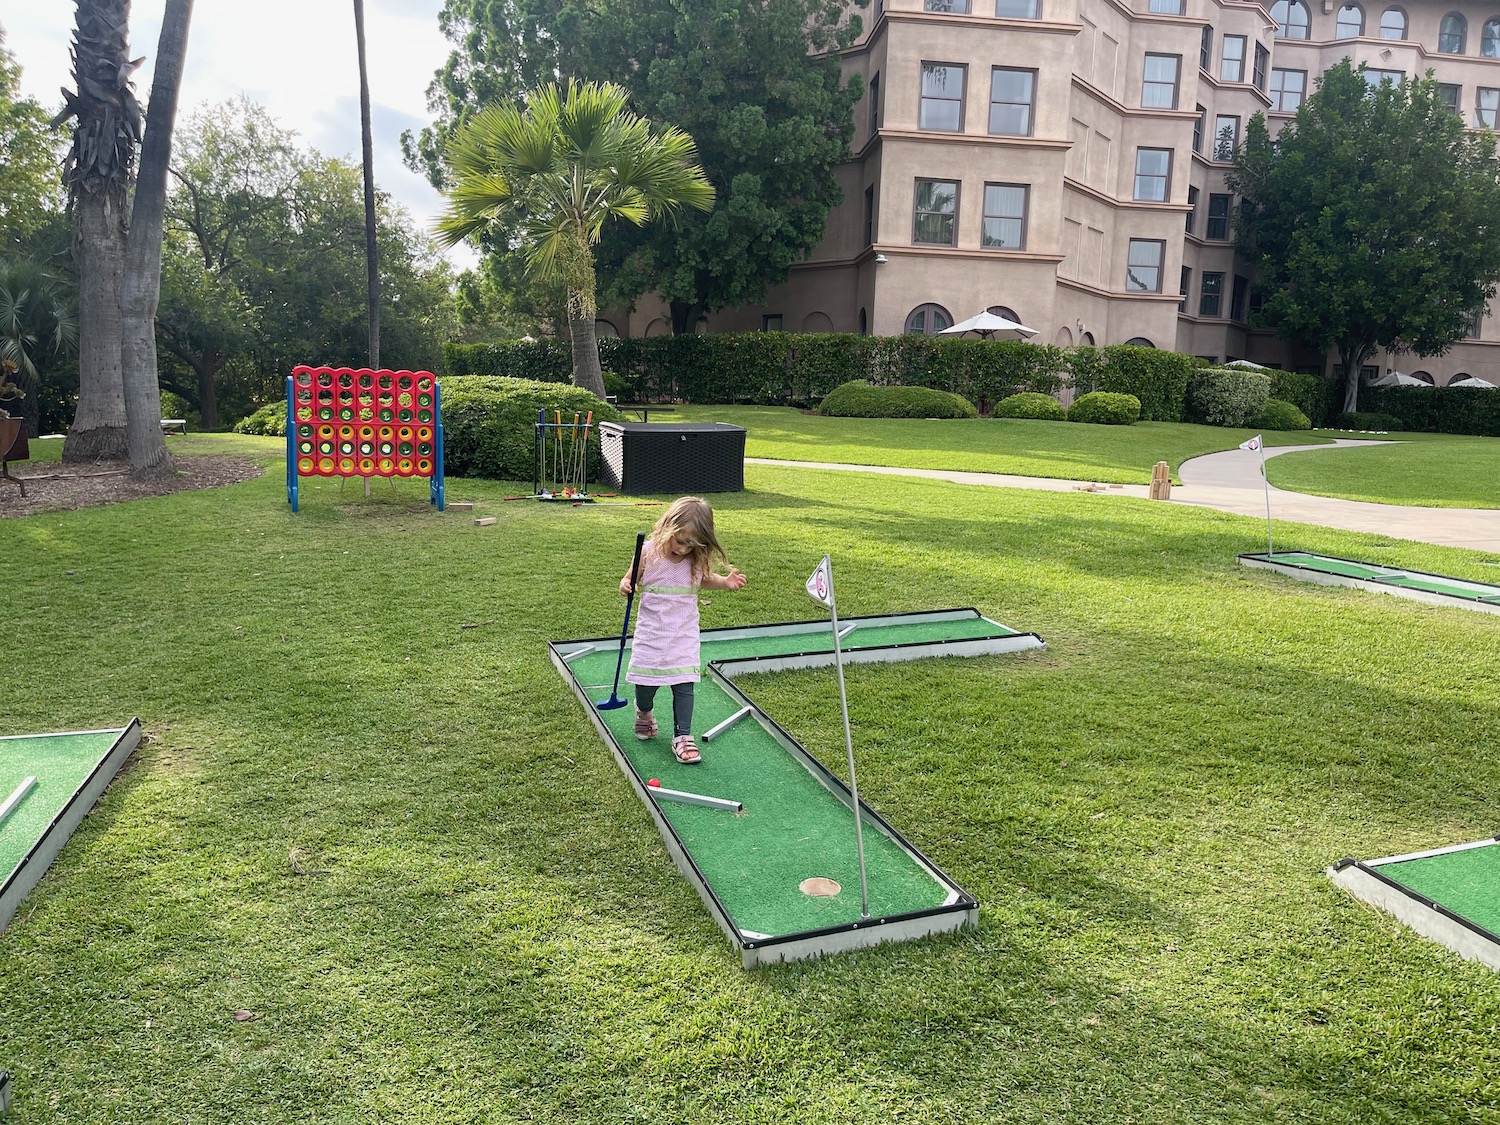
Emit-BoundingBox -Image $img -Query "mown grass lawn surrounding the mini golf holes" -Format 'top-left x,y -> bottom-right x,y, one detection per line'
0,435 -> 1500,1125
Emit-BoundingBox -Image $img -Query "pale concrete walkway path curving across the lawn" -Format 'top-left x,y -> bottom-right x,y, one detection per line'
746,438 -> 1500,554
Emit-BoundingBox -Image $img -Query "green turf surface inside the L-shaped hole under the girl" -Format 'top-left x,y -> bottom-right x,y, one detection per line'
569,615 -> 1014,938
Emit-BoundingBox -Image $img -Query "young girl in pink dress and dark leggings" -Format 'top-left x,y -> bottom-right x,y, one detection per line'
620,497 -> 746,765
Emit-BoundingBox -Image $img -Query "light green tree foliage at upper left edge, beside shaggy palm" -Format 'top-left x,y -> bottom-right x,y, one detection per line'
0,27 -> 63,254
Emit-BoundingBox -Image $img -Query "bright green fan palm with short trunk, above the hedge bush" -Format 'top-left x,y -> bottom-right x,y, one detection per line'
438,81 -> 714,398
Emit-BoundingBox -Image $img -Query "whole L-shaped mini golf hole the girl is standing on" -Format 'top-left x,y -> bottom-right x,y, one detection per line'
551,609 -> 1041,966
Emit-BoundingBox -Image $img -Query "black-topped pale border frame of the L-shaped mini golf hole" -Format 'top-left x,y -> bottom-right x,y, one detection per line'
548,609 -> 1046,969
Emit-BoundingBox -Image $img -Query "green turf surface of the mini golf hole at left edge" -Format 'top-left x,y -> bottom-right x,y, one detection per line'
0,731 -> 120,884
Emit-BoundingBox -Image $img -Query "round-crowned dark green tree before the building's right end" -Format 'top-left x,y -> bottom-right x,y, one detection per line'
1229,60 -> 1500,411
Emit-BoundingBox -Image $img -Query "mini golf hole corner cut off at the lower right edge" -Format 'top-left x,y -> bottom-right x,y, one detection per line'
1329,839 -> 1500,969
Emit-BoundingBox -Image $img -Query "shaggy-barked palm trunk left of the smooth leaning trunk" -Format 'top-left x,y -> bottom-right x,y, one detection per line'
53,0 -> 141,461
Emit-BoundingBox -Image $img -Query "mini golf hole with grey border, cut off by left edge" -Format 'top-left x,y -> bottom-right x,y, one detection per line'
0,720 -> 141,930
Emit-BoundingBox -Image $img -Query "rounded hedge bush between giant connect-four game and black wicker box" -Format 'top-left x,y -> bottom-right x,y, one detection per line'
438,375 -> 623,480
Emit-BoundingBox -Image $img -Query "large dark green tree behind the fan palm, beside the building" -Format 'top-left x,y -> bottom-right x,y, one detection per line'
404,0 -> 864,332
